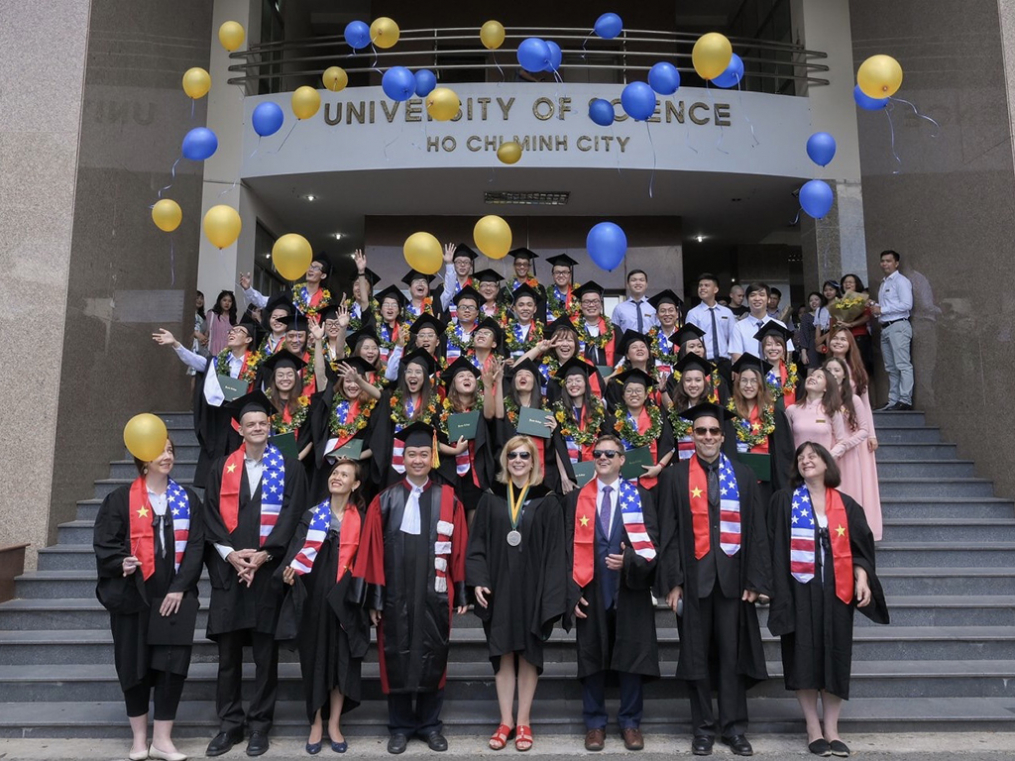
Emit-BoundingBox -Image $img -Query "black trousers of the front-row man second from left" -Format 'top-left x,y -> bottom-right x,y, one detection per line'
215,629 -> 278,734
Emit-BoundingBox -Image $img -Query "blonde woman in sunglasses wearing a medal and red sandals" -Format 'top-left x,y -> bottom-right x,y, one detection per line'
466,436 -> 567,751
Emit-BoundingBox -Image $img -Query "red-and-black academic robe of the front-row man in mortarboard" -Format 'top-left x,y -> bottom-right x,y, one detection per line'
356,485 -> 469,694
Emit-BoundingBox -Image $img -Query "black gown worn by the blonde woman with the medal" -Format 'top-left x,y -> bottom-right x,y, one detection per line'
465,484 -> 567,673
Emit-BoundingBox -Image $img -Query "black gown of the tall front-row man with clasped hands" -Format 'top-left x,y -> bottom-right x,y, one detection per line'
204,457 -> 307,639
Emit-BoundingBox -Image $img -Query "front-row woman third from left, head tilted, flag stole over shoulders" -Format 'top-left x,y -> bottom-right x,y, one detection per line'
282,460 -> 370,756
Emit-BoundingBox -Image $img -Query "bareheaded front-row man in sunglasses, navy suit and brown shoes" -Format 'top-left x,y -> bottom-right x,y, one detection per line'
563,435 -> 659,751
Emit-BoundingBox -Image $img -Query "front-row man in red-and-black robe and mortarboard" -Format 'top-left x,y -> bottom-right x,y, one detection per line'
353,422 -> 468,754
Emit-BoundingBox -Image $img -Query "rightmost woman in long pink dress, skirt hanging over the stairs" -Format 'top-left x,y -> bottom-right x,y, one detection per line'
824,357 -> 882,541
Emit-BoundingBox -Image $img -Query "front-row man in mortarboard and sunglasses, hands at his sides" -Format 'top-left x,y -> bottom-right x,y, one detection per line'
657,403 -> 771,756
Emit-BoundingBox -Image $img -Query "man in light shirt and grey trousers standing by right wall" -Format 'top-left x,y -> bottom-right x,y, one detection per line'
871,249 -> 915,411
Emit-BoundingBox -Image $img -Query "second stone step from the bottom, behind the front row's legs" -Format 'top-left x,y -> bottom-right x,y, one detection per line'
0,653 -> 1015,706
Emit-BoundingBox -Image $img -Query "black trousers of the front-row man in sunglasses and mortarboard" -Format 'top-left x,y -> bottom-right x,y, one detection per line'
688,580 -> 747,738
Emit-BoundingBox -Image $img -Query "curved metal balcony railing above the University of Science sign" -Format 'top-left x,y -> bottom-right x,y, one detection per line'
228,27 -> 828,95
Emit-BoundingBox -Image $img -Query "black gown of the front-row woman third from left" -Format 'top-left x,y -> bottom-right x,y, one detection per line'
277,502 -> 370,722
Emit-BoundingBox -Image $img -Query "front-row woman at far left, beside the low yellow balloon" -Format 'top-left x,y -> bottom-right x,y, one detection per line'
93,440 -> 204,761
